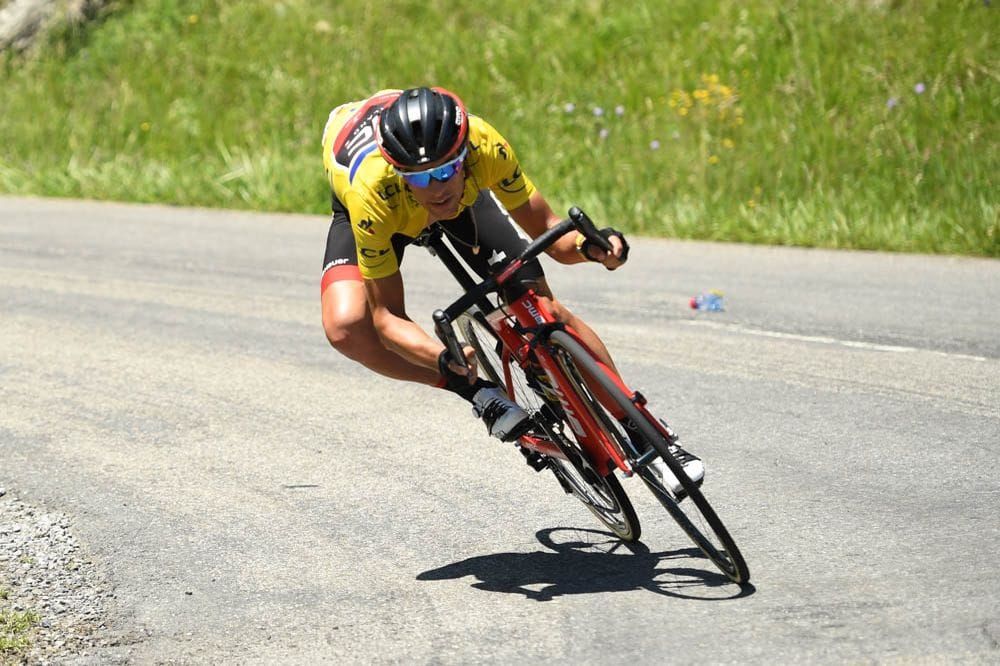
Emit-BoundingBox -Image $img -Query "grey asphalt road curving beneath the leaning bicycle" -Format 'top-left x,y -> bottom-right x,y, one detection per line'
0,198 -> 1000,664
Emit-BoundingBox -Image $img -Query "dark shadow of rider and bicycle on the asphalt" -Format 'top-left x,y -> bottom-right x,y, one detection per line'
417,528 -> 755,601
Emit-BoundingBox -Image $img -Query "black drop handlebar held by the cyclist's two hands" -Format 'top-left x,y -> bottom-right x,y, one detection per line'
432,206 -> 611,369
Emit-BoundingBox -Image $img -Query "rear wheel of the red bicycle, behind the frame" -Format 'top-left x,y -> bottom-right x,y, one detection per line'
456,311 -> 642,543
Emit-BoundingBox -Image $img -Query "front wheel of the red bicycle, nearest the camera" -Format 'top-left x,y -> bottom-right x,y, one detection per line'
548,331 -> 750,584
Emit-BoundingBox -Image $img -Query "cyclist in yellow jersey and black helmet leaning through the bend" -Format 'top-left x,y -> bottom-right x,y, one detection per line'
321,87 -> 704,490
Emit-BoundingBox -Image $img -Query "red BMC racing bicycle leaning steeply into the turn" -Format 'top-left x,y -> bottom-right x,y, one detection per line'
418,208 -> 750,583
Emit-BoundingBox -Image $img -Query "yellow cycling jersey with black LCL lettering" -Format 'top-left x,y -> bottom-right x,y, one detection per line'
323,90 -> 535,279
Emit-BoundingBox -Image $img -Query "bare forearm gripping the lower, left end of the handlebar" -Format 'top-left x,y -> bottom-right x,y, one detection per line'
365,271 -> 444,370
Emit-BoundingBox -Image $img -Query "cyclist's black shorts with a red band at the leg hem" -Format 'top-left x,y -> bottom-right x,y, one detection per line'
321,190 -> 545,293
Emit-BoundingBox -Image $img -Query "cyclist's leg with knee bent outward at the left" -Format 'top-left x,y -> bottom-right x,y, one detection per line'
320,198 -> 440,385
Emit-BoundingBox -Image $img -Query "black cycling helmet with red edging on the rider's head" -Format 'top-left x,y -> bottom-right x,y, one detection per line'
378,88 -> 469,168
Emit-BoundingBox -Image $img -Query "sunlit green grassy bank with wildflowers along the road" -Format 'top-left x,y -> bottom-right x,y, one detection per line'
0,0 -> 1000,257
